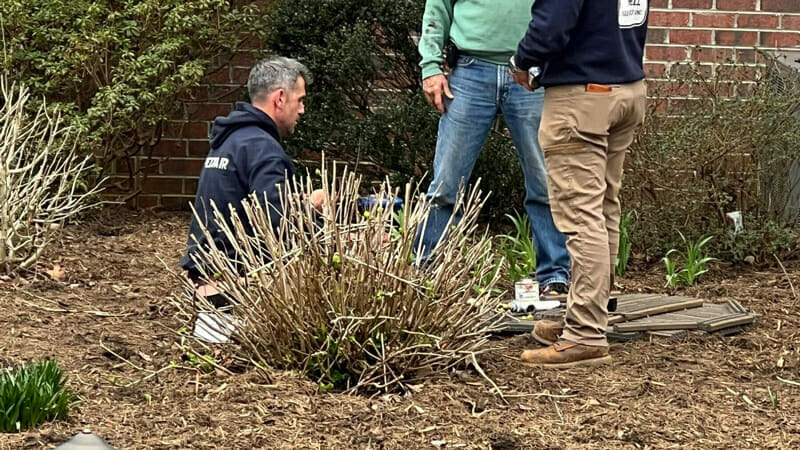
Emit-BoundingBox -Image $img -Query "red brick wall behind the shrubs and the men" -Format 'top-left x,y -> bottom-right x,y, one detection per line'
135,0 -> 800,208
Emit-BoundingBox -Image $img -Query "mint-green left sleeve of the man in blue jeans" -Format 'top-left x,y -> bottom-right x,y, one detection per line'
417,0 -> 454,80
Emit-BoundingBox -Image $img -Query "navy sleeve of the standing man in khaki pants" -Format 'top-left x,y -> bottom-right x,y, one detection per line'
514,0 -> 584,70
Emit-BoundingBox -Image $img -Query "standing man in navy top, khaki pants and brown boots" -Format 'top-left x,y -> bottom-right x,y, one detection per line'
509,0 -> 649,368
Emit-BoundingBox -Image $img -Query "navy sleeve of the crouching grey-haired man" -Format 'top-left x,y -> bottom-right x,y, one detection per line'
248,155 -> 294,228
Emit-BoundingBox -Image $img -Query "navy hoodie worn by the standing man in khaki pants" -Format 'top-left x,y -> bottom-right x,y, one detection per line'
514,0 -> 649,87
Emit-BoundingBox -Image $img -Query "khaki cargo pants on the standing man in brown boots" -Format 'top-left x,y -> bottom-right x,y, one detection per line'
539,81 -> 647,346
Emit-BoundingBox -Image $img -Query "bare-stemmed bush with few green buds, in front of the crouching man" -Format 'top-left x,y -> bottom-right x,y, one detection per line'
174,163 -> 498,391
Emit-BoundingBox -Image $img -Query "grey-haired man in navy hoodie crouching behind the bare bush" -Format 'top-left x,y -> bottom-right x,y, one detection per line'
181,57 -> 324,285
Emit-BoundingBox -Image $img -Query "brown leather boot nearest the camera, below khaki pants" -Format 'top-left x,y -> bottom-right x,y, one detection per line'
520,340 -> 611,369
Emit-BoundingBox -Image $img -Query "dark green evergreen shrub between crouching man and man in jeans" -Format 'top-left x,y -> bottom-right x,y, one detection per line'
270,0 -> 436,185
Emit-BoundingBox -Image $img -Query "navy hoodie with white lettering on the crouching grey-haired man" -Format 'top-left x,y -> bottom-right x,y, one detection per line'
181,102 -> 295,279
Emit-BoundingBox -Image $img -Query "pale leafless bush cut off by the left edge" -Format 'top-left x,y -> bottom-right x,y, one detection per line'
0,74 -> 104,273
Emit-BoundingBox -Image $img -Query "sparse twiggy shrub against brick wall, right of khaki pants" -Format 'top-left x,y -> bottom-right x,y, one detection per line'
622,63 -> 800,260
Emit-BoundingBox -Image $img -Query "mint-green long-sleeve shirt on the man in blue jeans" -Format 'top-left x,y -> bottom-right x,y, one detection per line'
419,0 -> 533,78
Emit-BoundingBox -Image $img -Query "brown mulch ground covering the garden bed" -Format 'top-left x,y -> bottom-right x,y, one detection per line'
0,210 -> 800,449
